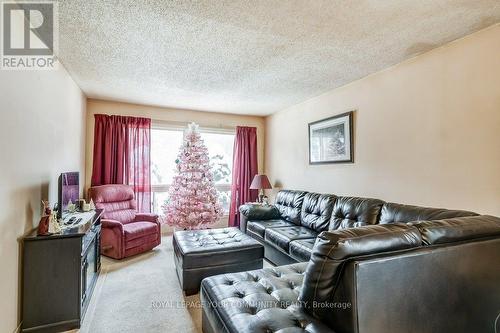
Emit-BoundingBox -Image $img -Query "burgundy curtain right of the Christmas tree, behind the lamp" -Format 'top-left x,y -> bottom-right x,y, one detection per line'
229,126 -> 257,227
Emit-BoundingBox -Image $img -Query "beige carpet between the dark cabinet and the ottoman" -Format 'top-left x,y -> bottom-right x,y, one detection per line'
79,236 -> 201,333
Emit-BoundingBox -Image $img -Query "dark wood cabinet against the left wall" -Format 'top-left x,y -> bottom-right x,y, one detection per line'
22,210 -> 102,332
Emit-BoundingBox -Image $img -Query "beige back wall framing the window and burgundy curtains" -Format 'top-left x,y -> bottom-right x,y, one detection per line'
85,99 -> 265,232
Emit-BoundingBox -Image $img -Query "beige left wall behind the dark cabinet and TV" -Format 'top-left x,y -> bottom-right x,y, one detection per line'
0,66 -> 85,332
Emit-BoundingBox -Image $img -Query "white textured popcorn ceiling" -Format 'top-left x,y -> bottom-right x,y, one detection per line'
59,0 -> 500,115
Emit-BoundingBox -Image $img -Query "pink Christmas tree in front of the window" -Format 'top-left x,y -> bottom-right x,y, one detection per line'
163,123 -> 223,230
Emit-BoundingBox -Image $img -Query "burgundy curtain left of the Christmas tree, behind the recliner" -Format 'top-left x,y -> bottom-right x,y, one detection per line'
91,114 -> 151,212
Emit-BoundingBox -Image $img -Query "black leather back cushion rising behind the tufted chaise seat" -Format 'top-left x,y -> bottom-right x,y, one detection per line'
299,223 -> 422,325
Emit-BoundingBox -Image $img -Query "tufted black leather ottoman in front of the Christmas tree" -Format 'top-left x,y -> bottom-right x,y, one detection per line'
173,228 -> 264,295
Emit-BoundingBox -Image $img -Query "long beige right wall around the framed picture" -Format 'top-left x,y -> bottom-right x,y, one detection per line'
265,25 -> 500,216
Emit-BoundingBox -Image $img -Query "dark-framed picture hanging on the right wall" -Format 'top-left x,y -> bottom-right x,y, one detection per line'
309,111 -> 354,164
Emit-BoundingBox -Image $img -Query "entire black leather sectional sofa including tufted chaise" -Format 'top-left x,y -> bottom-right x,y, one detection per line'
201,191 -> 500,333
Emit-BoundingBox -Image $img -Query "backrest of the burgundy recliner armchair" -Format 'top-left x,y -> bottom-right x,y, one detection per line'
89,184 -> 137,223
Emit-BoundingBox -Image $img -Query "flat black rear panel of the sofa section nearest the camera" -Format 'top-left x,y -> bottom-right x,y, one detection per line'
340,233 -> 500,333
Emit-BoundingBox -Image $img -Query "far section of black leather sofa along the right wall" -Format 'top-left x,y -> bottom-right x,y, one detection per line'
240,190 -> 477,265
